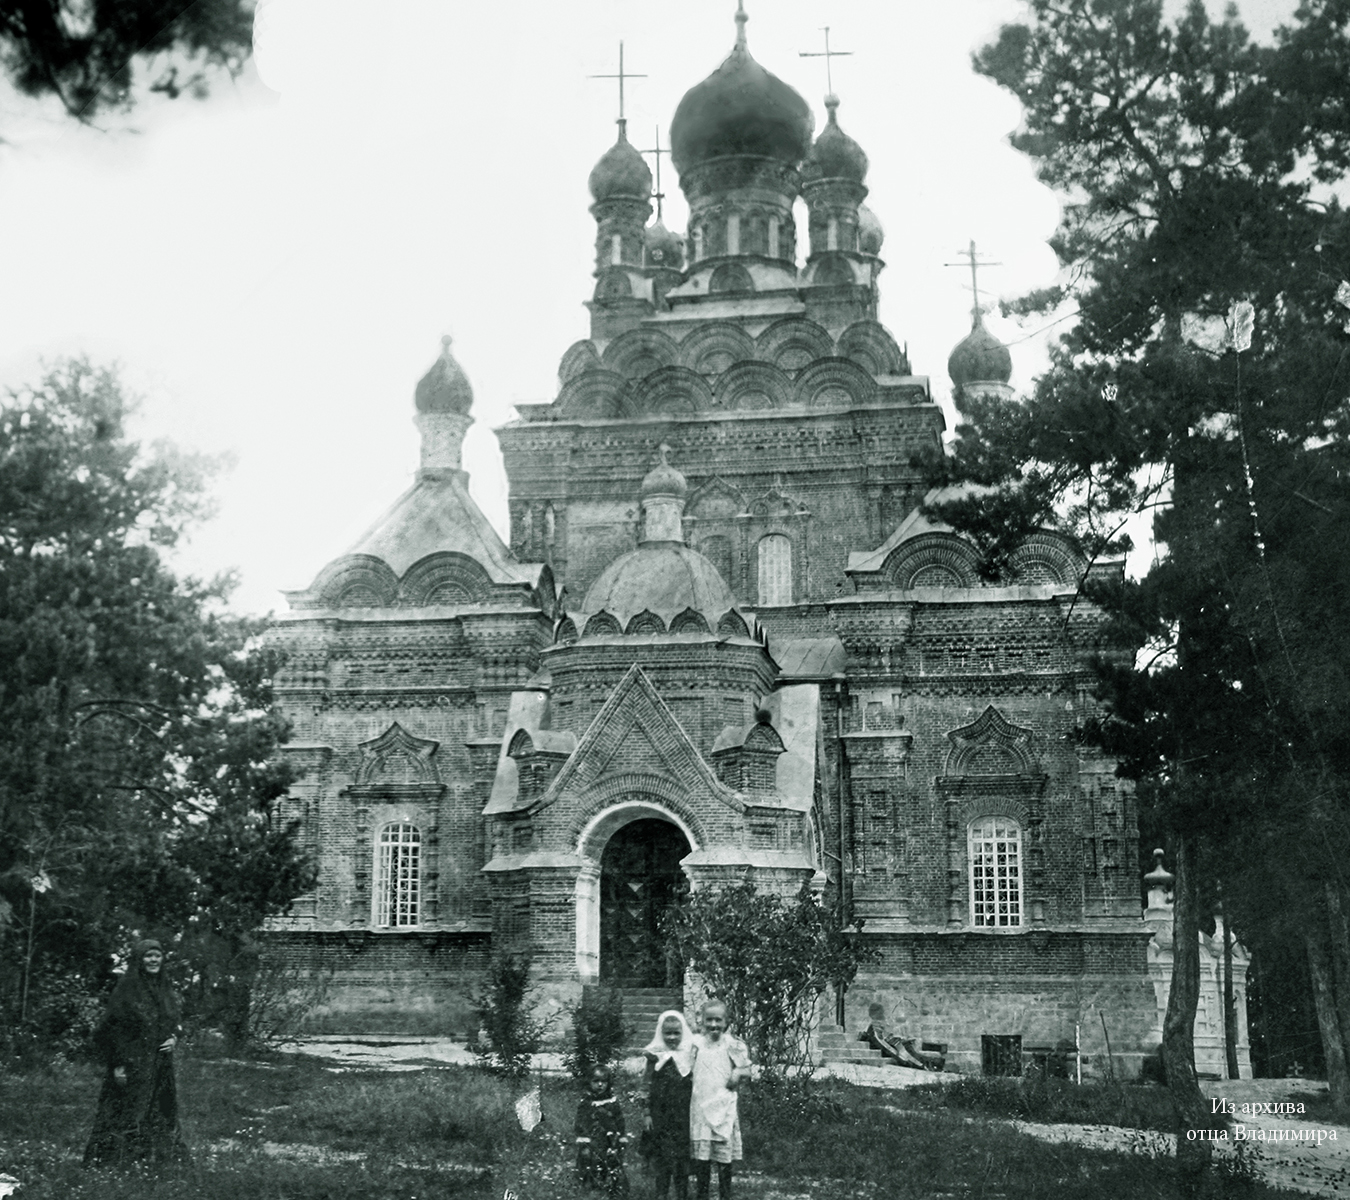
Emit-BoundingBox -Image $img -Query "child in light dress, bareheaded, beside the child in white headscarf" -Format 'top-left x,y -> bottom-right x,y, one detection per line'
689,1000 -> 751,1200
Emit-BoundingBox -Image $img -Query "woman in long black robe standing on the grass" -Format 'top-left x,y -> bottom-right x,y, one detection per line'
84,939 -> 188,1165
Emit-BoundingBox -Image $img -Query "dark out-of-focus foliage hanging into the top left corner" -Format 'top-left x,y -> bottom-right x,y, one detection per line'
0,0 -> 254,123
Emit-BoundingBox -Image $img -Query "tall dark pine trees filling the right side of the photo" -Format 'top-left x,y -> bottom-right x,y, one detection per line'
934,0 -> 1350,1123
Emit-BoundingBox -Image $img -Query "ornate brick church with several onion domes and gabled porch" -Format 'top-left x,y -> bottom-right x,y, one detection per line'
270,12 -> 1157,1070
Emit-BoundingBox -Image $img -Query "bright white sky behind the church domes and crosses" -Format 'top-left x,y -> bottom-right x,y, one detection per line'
0,0 -> 1293,613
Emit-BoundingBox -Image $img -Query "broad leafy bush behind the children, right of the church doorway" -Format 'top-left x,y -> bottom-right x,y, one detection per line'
667,883 -> 872,1074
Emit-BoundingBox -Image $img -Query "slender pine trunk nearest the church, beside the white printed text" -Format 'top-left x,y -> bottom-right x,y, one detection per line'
1162,837 -> 1214,1196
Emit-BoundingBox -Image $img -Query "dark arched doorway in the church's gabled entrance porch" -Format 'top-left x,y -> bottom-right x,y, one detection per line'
599,818 -> 690,988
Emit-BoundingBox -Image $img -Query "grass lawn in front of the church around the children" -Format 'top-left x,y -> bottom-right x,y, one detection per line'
0,1056 -> 1291,1200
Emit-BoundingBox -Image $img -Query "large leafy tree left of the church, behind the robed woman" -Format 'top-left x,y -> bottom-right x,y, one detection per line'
0,359 -> 313,1052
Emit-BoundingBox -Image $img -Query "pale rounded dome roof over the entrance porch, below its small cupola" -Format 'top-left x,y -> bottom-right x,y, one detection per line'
583,541 -> 736,629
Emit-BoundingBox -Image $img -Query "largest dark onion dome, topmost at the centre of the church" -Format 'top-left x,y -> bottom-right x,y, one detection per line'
671,12 -> 815,175
